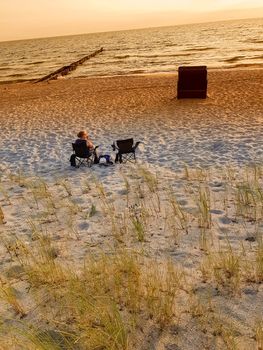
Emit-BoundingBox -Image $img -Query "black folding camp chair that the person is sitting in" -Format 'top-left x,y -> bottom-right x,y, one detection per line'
71,142 -> 99,168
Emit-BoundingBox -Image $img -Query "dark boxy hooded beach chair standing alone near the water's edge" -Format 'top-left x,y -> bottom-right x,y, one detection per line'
177,66 -> 207,98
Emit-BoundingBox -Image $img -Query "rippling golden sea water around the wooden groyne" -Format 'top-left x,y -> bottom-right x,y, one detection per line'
0,18 -> 263,81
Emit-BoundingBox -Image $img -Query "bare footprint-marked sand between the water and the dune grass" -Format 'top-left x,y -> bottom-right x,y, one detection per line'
0,69 -> 263,175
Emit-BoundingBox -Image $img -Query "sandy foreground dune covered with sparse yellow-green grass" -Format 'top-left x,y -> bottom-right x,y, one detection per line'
0,166 -> 263,350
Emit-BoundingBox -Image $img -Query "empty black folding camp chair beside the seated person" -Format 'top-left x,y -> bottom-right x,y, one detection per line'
112,138 -> 140,163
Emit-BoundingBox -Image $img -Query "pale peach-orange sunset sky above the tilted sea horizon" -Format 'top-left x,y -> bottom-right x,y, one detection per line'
0,0 -> 263,41
